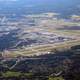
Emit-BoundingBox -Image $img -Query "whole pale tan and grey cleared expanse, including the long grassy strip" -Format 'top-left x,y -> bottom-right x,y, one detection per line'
2,13 -> 80,58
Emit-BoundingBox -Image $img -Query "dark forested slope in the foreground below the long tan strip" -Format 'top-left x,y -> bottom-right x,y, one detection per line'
0,45 -> 80,80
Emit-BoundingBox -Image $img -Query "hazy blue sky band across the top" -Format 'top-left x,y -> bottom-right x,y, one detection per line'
0,0 -> 80,15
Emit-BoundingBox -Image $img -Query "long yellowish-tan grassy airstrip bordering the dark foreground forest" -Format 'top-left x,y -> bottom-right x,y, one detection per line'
3,40 -> 80,58
